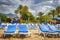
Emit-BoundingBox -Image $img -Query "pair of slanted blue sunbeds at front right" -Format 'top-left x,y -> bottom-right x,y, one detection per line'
39,24 -> 60,36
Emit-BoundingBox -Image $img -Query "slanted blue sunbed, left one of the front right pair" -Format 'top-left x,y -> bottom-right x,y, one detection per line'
39,24 -> 58,36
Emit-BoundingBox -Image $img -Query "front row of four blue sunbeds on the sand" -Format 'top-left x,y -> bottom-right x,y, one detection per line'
2,24 -> 60,36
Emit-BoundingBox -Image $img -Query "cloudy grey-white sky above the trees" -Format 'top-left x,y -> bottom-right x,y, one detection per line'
0,0 -> 60,15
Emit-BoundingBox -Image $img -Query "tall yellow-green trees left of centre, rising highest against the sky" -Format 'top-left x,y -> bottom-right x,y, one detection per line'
15,5 -> 34,21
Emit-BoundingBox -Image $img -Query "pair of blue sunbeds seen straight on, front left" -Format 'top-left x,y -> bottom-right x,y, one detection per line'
1,24 -> 31,37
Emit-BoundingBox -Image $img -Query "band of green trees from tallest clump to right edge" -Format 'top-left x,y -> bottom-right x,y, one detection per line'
15,5 -> 60,22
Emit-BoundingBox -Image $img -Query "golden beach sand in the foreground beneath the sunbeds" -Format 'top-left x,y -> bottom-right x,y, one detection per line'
0,29 -> 60,40
